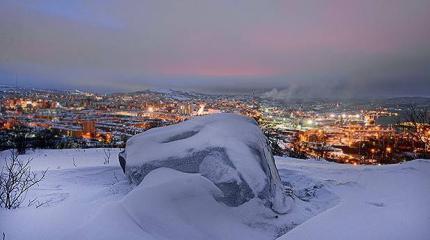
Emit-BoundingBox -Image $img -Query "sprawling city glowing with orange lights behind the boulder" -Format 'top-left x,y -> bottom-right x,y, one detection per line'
0,88 -> 430,164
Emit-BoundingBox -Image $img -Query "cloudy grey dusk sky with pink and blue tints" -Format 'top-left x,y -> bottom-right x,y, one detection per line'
0,0 -> 430,97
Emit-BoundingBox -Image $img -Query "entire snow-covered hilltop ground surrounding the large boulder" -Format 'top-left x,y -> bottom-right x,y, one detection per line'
0,149 -> 430,240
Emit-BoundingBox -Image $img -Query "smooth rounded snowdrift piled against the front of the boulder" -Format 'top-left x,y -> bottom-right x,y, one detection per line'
72,168 -> 282,240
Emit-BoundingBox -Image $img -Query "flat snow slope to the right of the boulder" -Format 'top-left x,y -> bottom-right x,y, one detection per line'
277,158 -> 430,240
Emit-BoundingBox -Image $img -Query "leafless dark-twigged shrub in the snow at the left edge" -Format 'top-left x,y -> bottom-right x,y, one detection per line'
0,151 -> 48,209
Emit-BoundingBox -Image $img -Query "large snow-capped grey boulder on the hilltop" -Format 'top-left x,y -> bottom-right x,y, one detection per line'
119,113 -> 292,213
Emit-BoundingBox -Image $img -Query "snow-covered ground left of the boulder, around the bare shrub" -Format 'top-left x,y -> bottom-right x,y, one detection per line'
0,149 -> 131,240
